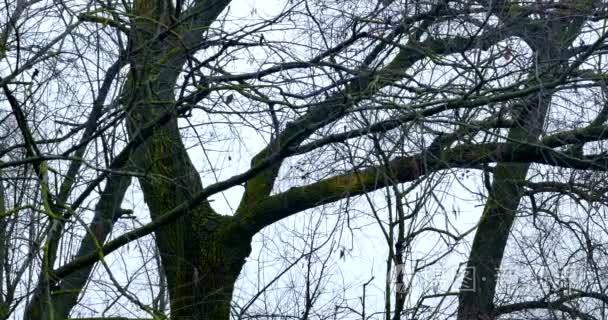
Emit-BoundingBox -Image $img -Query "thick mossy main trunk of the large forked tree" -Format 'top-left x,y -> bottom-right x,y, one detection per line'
122,13 -> 251,320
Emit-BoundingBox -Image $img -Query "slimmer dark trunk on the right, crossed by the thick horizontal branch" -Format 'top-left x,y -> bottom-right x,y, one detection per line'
457,8 -> 582,320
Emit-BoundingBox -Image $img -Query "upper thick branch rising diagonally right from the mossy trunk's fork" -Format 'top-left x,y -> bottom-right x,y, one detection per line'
237,24 -> 508,214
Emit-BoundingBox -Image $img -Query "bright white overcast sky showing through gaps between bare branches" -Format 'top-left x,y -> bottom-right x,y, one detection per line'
4,0 -> 608,318
